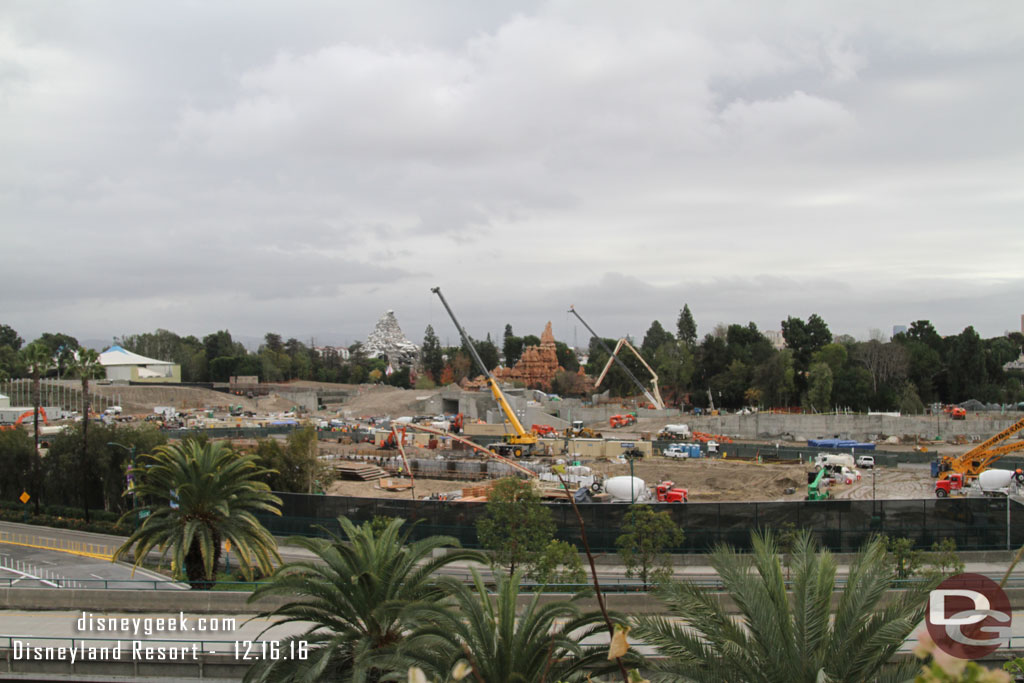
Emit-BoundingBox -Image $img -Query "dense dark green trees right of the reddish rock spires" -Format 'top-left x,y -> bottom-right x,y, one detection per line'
586,306 -> 1024,414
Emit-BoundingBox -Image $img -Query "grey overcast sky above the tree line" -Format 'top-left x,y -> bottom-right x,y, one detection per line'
0,0 -> 1024,352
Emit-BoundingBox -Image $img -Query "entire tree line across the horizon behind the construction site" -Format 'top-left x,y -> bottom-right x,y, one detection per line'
0,305 -> 1024,413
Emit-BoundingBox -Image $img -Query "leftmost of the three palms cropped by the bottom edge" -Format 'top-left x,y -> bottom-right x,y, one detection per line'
246,517 -> 486,682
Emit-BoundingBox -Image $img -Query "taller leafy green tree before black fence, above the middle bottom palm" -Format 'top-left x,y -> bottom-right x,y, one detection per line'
476,477 -> 555,575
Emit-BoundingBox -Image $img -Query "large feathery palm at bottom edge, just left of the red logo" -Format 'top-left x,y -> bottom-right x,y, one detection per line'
633,531 -> 937,683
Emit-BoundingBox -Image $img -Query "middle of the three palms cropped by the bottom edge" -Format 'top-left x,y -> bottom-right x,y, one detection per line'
392,569 -> 615,683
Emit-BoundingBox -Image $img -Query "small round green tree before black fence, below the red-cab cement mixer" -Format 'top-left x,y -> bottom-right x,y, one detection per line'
615,505 -> 683,588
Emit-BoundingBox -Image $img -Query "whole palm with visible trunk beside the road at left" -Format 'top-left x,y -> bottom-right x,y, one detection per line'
114,439 -> 281,589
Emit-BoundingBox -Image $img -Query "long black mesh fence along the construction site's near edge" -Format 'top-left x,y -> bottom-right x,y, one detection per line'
260,494 -> 1024,553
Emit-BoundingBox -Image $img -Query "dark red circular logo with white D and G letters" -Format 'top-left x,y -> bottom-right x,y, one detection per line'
925,573 -> 1013,659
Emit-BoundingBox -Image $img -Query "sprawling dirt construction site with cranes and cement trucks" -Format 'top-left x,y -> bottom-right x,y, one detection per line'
8,289 -> 1024,543
